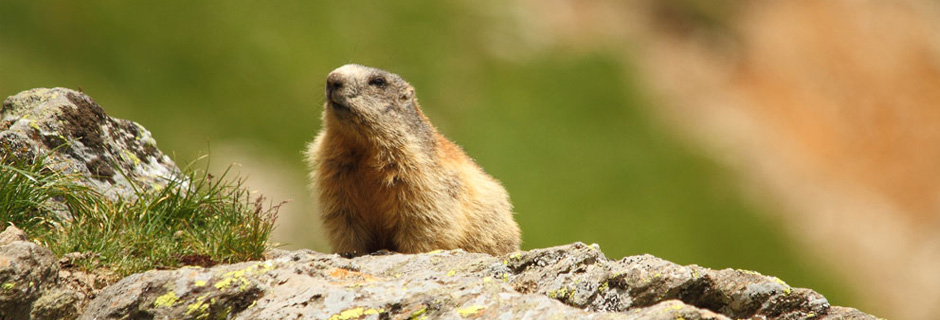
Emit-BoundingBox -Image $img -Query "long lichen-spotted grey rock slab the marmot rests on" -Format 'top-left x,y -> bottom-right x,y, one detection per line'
81,243 -> 875,320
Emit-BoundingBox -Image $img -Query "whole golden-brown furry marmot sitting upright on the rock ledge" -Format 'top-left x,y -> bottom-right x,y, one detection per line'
306,64 -> 520,255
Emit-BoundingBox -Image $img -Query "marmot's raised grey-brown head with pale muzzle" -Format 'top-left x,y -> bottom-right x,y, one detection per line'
324,64 -> 432,139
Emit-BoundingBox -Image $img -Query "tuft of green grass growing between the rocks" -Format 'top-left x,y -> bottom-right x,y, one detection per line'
0,152 -> 279,276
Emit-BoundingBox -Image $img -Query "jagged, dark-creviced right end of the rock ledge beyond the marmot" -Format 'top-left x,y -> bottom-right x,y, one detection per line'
507,243 -> 830,319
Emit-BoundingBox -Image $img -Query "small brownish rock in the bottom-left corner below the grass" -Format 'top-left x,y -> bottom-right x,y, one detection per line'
0,227 -> 59,319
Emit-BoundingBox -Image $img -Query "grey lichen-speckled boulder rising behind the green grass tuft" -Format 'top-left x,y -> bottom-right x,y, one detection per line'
0,88 -> 182,205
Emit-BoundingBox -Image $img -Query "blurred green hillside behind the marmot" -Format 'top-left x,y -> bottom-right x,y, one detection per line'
0,0 -> 856,306
